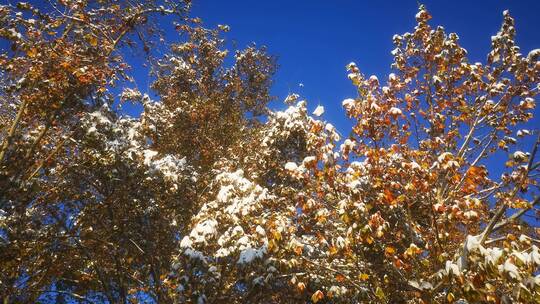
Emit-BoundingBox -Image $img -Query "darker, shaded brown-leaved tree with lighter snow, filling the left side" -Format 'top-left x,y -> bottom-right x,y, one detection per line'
0,1 -> 274,303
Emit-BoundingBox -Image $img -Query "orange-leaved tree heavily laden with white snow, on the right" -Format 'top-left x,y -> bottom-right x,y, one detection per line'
174,7 -> 540,303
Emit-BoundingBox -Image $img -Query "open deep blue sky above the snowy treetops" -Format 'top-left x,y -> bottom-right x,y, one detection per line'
187,0 -> 540,135
